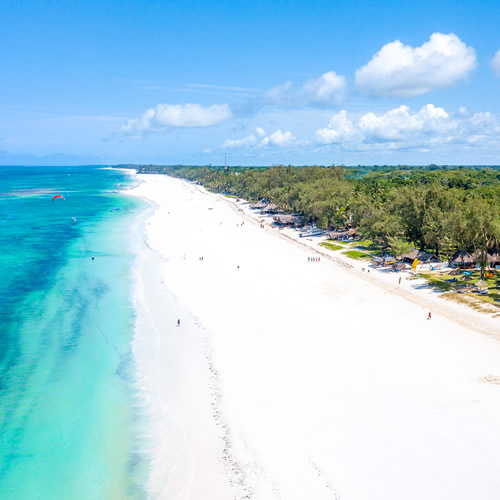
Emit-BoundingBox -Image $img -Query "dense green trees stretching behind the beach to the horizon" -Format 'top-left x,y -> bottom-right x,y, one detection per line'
124,165 -> 500,280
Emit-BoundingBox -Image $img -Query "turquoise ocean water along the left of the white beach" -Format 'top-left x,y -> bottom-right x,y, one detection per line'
0,167 -> 147,500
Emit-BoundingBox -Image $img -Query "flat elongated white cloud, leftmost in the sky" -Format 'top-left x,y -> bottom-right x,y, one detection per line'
120,104 -> 231,137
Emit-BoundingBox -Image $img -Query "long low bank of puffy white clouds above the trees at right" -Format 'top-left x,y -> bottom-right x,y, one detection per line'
316,104 -> 500,150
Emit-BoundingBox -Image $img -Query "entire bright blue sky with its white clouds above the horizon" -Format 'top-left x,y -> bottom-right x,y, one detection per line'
0,0 -> 500,165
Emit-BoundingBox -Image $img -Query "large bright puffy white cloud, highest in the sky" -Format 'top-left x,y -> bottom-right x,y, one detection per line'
355,33 -> 476,97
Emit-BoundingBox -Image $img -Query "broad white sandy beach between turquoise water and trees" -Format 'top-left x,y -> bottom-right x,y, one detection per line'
129,175 -> 500,500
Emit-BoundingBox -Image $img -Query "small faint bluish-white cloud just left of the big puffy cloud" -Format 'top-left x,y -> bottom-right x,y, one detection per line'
263,71 -> 346,107
